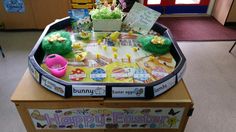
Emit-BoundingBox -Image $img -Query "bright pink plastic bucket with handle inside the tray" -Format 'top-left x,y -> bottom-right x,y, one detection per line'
45,54 -> 68,78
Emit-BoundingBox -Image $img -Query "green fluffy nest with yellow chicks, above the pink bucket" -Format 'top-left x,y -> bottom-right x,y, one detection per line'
42,31 -> 72,55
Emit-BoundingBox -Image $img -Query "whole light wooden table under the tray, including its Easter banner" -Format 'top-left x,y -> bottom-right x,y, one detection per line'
11,70 -> 193,132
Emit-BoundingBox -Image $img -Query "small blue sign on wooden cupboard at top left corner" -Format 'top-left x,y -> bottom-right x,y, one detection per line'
3,0 -> 25,13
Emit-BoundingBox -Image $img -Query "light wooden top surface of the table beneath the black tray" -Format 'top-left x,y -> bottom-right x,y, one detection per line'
11,69 -> 192,103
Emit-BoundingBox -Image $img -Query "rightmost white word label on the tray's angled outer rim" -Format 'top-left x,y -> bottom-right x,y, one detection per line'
153,76 -> 176,96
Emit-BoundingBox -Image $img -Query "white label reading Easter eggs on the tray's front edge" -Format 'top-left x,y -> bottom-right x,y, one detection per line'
112,87 -> 145,98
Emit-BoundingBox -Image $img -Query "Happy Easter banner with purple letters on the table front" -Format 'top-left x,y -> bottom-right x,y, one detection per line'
28,107 -> 184,130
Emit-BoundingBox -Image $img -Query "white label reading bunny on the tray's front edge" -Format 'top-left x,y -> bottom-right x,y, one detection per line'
72,85 -> 106,96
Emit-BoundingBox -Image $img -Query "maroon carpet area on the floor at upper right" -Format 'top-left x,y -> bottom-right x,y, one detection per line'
158,17 -> 236,41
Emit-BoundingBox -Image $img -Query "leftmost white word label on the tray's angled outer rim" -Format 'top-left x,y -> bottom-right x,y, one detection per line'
41,76 -> 65,96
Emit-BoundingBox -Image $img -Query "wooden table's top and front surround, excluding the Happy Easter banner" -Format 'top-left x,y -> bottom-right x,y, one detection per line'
11,70 -> 193,132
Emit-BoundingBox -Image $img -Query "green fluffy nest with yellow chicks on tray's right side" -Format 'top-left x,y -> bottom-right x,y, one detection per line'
138,36 -> 172,55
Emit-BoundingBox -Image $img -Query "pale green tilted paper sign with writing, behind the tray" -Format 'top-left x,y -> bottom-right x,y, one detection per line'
124,2 -> 161,35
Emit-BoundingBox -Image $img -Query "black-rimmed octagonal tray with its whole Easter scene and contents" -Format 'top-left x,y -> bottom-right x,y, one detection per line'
28,3 -> 186,98
